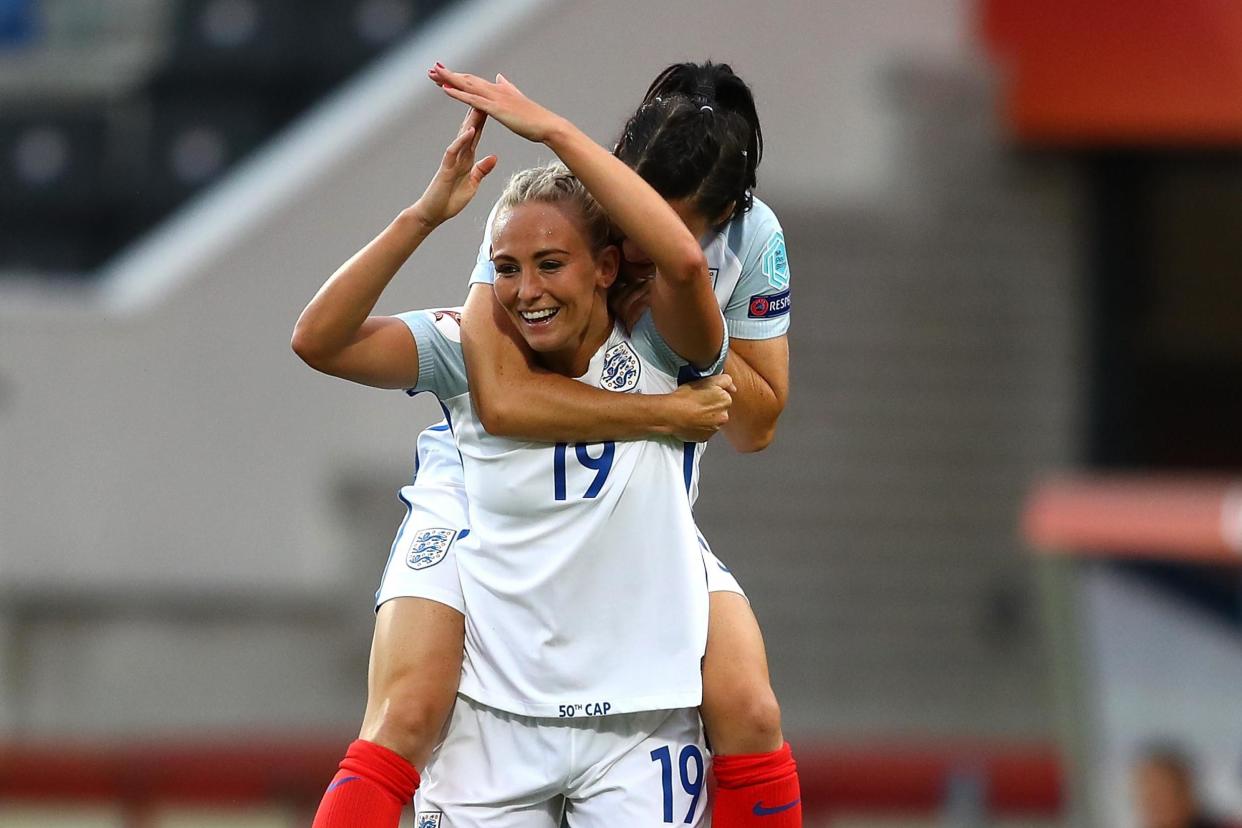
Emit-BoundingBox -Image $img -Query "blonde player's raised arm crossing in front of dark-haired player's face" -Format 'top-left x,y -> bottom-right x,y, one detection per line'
428,65 -> 724,367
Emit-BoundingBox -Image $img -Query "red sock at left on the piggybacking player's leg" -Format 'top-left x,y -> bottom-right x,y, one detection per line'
312,739 -> 419,828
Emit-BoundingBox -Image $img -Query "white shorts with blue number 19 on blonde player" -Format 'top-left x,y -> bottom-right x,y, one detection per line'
414,696 -> 710,828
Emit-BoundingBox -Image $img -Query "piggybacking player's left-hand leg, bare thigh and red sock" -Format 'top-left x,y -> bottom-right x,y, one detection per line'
313,597 -> 465,828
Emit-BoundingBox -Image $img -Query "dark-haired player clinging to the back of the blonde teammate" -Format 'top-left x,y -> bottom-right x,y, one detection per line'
306,63 -> 801,828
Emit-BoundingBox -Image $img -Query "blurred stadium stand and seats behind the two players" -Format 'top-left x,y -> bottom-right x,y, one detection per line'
0,0 -> 1242,828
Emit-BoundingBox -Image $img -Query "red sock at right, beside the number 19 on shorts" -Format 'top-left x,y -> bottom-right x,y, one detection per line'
712,742 -> 802,828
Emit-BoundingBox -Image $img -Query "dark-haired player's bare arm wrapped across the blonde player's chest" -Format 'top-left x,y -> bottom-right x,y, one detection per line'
462,284 -> 732,442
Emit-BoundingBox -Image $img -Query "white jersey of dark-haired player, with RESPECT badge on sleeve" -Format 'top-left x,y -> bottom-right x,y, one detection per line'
469,199 -> 790,503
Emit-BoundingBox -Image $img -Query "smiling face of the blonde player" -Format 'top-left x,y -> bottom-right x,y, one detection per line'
492,201 -> 619,376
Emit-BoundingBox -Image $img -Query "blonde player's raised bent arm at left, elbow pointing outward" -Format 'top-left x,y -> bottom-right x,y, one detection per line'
292,109 -> 496,389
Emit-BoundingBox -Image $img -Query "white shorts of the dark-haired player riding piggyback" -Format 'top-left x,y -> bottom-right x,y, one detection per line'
375,485 -> 746,614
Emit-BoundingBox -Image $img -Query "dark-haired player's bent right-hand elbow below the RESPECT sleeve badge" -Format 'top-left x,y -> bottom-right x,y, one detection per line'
724,336 -> 789,452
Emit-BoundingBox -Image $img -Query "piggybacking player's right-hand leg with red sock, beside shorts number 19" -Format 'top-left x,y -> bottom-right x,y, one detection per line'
699,550 -> 802,828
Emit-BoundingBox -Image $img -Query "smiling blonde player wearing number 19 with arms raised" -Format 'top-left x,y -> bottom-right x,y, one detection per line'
294,87 -> 728,828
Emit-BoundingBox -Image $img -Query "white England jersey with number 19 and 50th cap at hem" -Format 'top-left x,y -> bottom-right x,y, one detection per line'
401,310 -> 724,718
